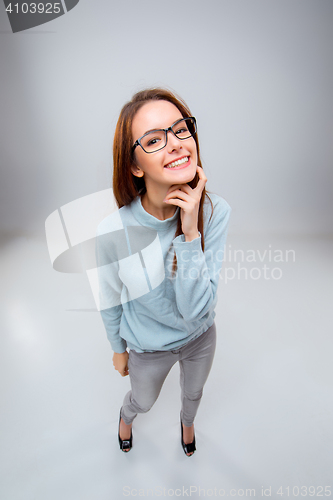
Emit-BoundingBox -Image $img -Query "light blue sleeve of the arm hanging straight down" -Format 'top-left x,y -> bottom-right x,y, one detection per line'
96,229 -> 127,353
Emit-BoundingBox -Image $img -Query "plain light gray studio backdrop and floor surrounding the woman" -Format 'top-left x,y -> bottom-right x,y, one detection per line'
0,0 -> 333,500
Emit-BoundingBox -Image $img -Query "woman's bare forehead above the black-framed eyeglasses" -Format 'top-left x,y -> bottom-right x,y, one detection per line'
132,101 -> 182,137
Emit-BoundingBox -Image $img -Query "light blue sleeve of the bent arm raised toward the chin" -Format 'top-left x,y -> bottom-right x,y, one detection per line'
173,197 -> 231,321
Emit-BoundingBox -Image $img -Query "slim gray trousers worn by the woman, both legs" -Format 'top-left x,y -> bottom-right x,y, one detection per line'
121,323 -> 216,427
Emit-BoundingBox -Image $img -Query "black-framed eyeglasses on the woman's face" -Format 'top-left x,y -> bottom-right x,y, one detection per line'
132,116 -> 197,153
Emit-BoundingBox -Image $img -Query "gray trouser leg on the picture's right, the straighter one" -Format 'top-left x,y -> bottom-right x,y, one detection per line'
179,323 -> 216,427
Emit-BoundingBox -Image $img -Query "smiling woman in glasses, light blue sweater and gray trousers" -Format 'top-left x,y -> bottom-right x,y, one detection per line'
97,88 -> 231,456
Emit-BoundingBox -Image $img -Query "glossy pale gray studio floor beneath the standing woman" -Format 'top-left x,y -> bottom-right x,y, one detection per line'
0,235 -> 333,500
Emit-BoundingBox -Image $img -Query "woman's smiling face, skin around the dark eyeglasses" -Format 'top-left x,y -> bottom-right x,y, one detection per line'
132,101 -> 197,191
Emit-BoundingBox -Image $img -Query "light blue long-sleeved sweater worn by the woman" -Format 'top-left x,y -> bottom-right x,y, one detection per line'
96,193 -> 231,352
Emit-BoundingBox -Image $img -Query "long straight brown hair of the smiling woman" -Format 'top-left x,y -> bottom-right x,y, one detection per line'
113,88 -> 208,268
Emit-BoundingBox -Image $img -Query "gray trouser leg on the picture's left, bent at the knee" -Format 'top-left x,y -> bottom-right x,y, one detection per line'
121,350 -> 178,425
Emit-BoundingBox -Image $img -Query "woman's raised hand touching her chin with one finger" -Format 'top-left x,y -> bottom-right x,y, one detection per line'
164,165 -> 207,241
